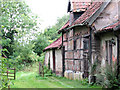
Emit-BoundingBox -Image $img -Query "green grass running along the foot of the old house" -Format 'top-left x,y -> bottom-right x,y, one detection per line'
10,64 -> 101,88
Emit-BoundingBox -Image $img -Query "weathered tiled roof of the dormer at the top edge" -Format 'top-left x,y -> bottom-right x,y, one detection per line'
72,0 -> 91,12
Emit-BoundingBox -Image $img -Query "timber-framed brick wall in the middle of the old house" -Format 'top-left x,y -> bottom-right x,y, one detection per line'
63,27 -> 89,72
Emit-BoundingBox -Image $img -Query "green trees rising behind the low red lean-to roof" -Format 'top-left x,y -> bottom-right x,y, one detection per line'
32,15 -> 68,56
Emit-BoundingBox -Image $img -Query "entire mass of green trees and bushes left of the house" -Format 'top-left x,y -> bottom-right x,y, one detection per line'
0,0 -> 68,87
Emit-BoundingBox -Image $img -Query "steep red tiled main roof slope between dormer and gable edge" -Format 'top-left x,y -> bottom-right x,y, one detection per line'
72,2 -> 103,26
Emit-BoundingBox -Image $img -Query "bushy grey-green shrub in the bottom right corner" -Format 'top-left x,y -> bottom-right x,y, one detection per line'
97,64 -> 120,89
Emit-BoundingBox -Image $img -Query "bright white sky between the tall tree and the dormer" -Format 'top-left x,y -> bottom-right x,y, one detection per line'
25,0 -> 69,30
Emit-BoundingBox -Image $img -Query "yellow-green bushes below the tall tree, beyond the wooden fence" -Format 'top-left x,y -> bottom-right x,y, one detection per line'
9,44 -> 39,70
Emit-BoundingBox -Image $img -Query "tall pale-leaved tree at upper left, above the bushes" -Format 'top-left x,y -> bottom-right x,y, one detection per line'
0,0 -> 38,58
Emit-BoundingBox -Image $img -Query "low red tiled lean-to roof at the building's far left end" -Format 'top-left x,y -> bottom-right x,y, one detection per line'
43,36 -> 62,51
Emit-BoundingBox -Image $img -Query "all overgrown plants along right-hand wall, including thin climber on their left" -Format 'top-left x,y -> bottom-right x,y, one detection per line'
90,59 -> 120,89
